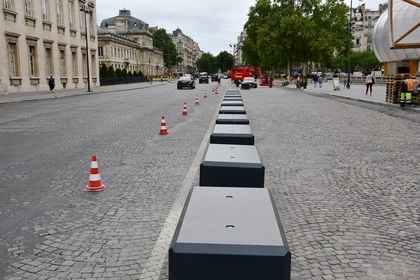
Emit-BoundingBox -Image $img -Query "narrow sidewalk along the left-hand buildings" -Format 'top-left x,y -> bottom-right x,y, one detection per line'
0,81 -> 167,104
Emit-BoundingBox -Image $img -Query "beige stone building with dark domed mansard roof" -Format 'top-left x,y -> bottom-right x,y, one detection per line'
98,9 -> 165,76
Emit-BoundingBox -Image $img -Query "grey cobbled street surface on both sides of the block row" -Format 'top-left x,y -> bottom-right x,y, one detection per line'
0,81 -> 420,280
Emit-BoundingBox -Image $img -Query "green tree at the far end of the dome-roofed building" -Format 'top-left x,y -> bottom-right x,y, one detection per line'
153,28 -> 182,72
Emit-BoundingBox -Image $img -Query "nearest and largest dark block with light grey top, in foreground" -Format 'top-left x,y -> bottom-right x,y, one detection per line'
169,187 -> 291,280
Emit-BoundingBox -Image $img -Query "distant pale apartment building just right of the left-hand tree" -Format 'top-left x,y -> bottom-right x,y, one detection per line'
170,28 -> 203,75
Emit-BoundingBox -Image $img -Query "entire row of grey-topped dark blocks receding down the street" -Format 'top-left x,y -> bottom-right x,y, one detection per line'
169,88 -> 291,280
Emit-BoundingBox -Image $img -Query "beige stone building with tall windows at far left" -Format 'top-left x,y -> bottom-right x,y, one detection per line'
0,0 -> 99,93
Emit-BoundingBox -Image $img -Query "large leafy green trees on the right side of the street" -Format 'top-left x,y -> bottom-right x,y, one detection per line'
242,0 -> 381,75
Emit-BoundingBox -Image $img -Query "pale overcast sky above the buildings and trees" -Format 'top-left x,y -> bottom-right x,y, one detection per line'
96,0 -> 386,56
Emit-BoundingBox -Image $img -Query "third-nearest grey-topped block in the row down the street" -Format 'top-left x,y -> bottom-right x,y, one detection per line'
210,124 -> 255,145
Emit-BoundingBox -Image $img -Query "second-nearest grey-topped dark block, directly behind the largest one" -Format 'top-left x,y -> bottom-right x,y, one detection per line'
200,144 -> 265,188
